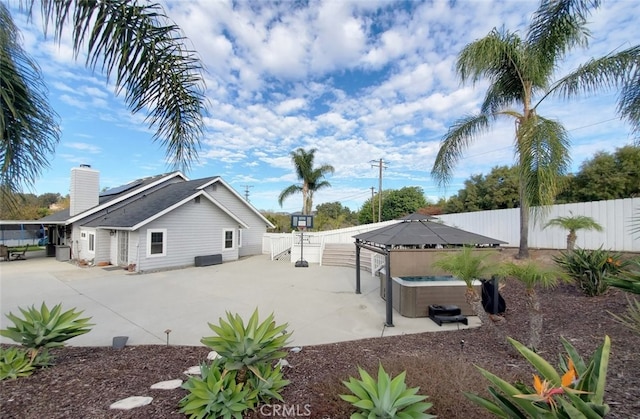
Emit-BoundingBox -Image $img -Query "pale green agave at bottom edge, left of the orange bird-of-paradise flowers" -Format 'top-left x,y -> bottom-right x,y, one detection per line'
340,364 -> 435,419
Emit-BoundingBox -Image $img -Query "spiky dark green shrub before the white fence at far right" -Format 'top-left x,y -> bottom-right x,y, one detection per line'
553,248 -> 627,297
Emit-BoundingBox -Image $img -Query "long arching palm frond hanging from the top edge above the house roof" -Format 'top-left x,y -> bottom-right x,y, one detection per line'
27,0 -> 205,170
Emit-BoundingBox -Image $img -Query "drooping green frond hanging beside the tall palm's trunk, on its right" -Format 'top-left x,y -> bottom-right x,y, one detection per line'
516,114 -> 571,206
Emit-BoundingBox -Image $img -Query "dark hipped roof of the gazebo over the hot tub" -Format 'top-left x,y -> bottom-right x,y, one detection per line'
354,213 -> 506,246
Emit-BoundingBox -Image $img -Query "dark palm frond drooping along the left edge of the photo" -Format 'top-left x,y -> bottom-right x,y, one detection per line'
0,3 -> 60,202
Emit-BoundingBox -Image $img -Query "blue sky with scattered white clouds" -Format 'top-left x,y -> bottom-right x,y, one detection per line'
13,0 -> 640,212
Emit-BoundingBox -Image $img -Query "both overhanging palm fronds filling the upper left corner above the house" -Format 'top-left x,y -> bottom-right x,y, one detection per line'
0,0 -> 205,200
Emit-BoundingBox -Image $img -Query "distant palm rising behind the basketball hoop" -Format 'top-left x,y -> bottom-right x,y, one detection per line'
278,147 -> 334,215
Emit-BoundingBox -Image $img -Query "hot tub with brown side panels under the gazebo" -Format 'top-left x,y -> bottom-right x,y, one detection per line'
380,275 -> 480,317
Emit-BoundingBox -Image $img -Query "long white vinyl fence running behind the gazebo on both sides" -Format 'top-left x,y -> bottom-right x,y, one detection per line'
262,198 -> 640,263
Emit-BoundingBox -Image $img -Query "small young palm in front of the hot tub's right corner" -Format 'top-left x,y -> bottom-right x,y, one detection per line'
433,246 -> 497,324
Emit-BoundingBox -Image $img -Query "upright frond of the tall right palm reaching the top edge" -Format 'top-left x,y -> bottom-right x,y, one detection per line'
526,0 -> 600,77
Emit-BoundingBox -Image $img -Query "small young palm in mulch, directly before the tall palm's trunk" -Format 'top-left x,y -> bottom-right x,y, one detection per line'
500,261 -> 563,350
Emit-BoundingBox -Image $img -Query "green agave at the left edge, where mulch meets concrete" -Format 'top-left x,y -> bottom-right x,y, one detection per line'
0,302 -> 93,357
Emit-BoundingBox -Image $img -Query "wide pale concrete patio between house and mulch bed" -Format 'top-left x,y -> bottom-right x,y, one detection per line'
0,252 -> 479,346
